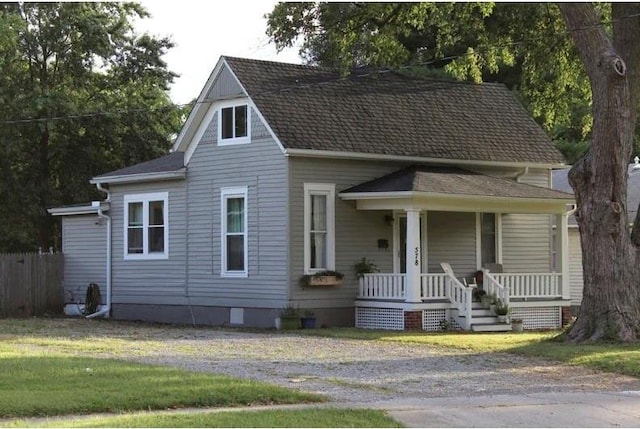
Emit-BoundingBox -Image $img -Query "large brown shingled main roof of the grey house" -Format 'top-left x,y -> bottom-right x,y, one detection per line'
224,57 -> 564,164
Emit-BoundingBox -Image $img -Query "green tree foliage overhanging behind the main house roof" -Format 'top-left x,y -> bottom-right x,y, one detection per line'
267,2 -> 610,162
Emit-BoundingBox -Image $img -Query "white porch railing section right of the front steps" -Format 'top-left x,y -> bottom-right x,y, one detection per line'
485,273 -> 562,298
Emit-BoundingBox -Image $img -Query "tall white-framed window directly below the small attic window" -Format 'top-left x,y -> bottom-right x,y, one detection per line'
220,186 -> 248,277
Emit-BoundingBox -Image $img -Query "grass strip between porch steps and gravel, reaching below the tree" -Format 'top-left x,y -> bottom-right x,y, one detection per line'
300,328 -> 640,377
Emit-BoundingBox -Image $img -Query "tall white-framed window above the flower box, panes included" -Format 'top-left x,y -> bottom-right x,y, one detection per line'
304,183 -> 335,273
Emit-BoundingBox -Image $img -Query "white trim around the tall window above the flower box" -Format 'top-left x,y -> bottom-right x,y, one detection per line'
304,183 -> 336,274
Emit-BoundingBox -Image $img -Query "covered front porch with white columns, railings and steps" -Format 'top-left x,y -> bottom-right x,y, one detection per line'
340,167 -> 573,330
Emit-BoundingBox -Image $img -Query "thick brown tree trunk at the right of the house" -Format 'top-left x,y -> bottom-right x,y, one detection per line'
560,3 -> 640,341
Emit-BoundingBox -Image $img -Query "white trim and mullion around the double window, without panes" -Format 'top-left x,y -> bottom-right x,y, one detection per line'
123,192 -> 169,260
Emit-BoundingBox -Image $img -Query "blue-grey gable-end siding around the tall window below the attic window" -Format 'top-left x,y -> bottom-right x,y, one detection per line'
187,109 -> 288,308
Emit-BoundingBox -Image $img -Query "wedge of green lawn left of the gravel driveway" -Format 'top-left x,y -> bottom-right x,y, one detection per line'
0,345 -> 323,418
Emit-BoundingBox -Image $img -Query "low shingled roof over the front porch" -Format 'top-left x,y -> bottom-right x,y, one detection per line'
341,166 -> 573,199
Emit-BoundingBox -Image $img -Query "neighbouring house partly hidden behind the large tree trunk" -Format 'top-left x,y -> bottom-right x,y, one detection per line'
552,156 -> 640,314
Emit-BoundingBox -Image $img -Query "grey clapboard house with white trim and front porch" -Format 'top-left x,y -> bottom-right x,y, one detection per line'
50,57 -> 573,330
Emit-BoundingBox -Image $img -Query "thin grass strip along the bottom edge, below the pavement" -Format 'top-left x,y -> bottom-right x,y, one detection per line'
6,408 -> 402,428
